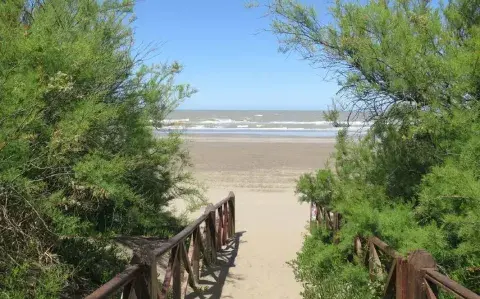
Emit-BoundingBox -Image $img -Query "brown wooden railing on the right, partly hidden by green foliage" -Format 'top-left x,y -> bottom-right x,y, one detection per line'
310,204 -> 480,299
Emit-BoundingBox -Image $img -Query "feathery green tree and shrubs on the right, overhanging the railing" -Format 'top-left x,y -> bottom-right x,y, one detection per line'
269,0 -> 480,298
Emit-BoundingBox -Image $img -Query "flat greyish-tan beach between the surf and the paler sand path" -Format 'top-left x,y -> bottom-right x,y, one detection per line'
186,136 -> 335,194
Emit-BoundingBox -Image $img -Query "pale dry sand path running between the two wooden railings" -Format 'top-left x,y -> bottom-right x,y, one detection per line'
186,189 -> 308,299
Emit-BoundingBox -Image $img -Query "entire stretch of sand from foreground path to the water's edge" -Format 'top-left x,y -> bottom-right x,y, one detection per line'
186,136 -> 335,298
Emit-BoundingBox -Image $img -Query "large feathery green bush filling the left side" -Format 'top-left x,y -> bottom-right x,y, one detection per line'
0,0 -> 201,298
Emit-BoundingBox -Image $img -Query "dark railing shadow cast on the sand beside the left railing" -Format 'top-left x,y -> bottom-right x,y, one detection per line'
185,231 -> 245,299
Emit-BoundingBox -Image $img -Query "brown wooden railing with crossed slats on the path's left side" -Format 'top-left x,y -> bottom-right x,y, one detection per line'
86,192 -> 235,299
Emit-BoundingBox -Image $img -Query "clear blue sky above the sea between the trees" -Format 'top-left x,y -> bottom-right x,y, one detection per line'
134,0 -> 339,110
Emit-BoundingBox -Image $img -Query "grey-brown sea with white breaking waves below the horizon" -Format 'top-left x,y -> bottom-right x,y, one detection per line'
159,110 -> 369,137
